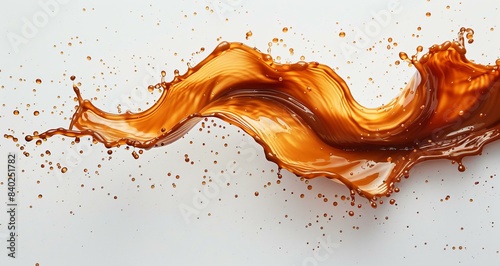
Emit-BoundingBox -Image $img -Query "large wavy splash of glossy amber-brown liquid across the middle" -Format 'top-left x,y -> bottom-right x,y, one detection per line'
26,28 -> 500,207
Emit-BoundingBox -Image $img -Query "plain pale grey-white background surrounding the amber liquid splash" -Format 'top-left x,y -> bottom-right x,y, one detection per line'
0,0 -> 500,266
